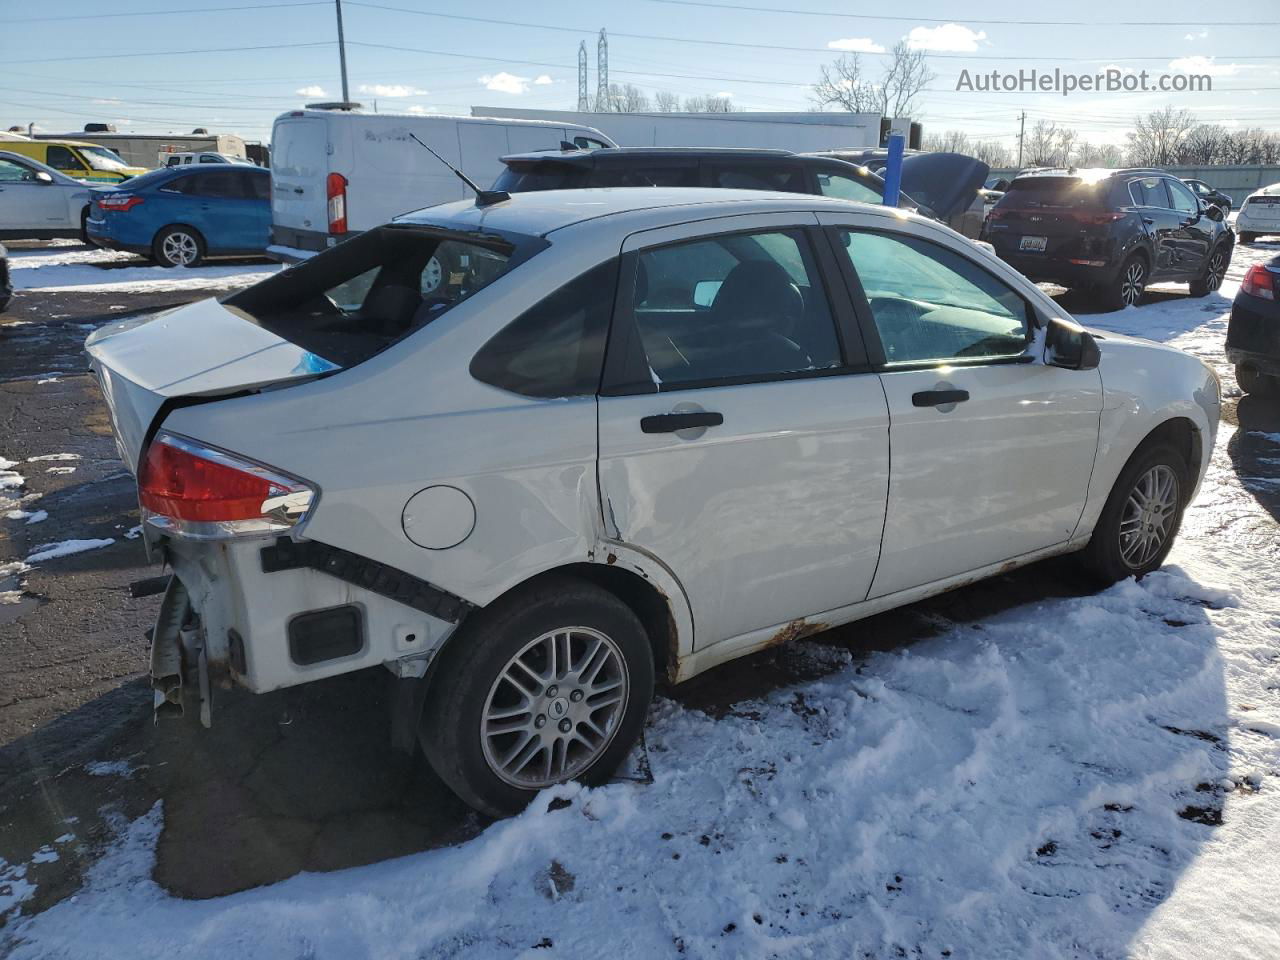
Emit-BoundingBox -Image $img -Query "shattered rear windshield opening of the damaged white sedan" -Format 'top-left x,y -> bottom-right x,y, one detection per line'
223,224 -> 547,372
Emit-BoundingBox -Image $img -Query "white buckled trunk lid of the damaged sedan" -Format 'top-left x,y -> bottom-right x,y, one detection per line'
84,300 -> 337,472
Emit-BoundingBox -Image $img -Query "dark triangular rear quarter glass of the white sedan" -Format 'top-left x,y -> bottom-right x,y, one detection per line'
471,260 -> 618,397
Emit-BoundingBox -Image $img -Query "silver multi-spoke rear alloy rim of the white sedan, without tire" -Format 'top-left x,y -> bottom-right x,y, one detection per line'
480,627 -> 631,790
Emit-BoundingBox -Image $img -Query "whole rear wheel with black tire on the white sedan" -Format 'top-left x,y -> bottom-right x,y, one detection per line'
419,577 -> 654,817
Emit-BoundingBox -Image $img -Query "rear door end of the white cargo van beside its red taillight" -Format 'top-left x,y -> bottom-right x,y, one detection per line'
271,116 -> 329,251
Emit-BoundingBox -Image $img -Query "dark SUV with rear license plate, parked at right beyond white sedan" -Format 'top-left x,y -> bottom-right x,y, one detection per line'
983,169 -> 1235,310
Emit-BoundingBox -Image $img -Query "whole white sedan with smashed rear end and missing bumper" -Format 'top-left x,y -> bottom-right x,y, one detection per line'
87,187 -> 1220,814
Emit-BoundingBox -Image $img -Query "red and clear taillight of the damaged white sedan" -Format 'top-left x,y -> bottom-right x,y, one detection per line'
138,431 -> 315,540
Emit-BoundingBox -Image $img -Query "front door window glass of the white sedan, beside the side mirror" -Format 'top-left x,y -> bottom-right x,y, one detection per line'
840,230 -> 1030,364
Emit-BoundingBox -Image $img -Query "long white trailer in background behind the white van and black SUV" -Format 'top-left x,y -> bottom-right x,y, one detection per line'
471,106 -> 910,154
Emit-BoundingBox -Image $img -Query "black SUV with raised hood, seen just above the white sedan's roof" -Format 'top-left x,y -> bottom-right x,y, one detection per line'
493,147 -> 989,238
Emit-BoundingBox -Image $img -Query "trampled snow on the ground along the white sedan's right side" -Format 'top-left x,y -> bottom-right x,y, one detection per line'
0,241 -> 1280,960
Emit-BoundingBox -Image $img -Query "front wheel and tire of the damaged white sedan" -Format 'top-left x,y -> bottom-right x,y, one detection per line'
1080,443 -> 1190,585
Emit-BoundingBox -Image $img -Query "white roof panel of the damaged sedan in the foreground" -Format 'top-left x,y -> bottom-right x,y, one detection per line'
396,187 -> 911,237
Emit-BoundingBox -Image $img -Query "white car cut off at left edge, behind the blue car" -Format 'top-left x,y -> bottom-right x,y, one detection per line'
0,150 -> 108,239
